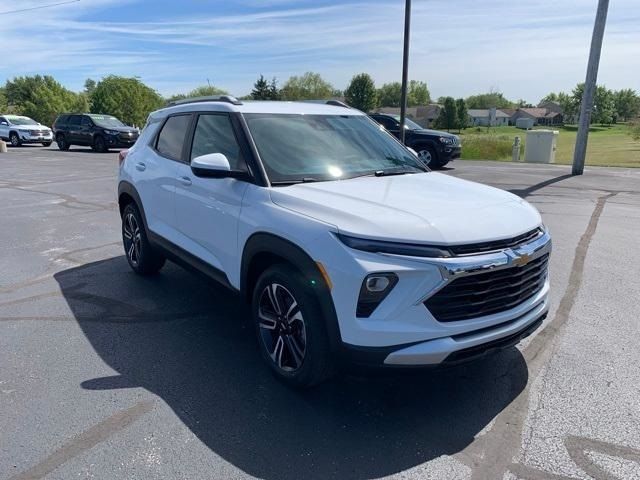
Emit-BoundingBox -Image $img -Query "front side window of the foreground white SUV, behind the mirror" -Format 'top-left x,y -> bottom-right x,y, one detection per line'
191,115 -> 246,170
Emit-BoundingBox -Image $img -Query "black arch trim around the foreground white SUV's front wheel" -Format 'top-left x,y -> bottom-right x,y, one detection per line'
240,233 -> 342,353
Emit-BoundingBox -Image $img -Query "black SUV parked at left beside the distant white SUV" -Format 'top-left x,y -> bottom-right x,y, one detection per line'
53,113 -> 140,152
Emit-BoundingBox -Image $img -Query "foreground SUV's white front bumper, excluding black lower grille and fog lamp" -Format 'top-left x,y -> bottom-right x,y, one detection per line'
318,232 -> 551,367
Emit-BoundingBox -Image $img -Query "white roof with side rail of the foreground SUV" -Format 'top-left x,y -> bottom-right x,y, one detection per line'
151,100 -> 358,117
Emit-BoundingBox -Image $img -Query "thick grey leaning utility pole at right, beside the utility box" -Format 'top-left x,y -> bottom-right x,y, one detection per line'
571,0 -> 609,175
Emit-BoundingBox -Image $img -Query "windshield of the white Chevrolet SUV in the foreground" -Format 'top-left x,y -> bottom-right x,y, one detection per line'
245,113 -> 427,183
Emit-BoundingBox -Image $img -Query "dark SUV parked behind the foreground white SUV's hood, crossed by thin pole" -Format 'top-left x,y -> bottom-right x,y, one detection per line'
370,113 -> 462,168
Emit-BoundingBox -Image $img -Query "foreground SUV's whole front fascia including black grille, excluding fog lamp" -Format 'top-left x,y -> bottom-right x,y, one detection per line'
322,229 -> 551,367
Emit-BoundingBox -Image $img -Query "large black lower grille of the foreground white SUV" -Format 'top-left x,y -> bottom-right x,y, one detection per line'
424,253 -> 549,322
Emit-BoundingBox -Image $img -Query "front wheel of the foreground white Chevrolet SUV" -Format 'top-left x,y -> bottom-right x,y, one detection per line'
251,264 -> 333,388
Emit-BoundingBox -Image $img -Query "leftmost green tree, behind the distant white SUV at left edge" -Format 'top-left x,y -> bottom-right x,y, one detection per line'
5,75 -> 89,125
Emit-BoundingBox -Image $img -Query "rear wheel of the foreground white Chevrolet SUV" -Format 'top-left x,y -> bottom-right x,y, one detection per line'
122,203 -> 166,276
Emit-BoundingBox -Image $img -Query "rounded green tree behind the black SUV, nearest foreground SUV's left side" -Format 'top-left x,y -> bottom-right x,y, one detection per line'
91,75 -> 164,125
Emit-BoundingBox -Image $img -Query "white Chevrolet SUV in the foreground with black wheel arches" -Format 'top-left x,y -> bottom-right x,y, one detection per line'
118,96 -> 551,386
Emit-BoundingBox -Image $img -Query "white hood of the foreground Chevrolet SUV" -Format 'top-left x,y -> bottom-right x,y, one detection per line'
271,172 -> 541,245
